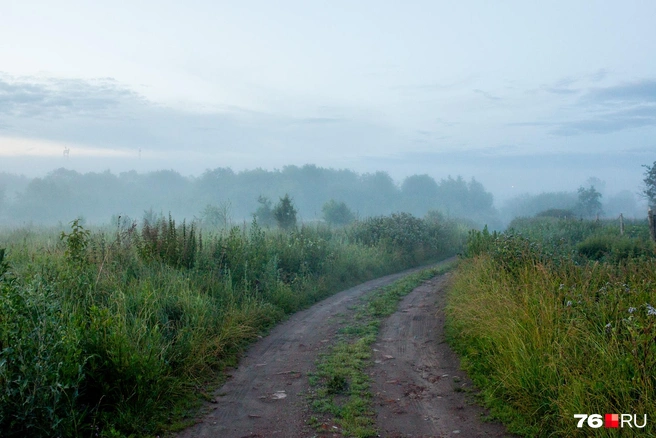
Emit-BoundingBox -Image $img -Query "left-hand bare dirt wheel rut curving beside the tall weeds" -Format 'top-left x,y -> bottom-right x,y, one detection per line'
177,269 -> 428,438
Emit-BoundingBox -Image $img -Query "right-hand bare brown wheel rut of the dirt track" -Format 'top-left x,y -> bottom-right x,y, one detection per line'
371,274 -> 511,438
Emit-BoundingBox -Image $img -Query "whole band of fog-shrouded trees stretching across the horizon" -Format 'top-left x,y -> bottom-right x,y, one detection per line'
0,165 -> 646,230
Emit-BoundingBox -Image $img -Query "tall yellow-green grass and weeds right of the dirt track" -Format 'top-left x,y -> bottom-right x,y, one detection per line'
447,216 -> 656,437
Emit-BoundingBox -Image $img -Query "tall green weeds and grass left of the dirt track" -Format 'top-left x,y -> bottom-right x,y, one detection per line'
0,210 -> 466,437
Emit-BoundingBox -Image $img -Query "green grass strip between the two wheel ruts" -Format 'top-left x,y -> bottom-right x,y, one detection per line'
310,263 -> 453,438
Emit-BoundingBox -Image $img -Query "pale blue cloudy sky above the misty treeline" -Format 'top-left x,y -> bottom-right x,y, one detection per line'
0,0 -> 656,203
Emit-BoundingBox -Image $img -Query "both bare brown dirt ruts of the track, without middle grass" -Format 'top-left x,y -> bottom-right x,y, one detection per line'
177,264 -> 509,438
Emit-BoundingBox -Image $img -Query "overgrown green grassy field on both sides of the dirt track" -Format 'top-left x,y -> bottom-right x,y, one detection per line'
5,214 -> 656,437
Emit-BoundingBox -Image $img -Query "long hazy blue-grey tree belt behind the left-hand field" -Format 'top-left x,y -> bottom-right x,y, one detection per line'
0,165 -> 498,229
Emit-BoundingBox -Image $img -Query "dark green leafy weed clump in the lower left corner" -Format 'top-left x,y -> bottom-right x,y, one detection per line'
0,248 -> 85,437
